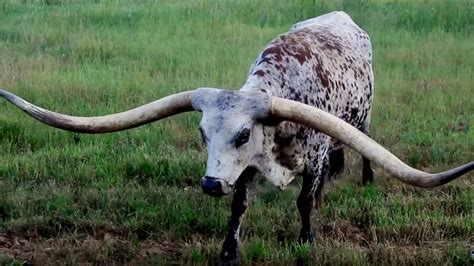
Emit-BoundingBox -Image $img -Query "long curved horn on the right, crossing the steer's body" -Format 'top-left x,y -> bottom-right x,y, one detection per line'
271,97 -> 474,188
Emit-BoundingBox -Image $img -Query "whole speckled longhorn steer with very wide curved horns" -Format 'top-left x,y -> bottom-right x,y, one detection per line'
0,12 -> 474,262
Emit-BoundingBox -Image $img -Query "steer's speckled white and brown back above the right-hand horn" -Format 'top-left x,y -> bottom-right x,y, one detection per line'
242,11 -> 373,129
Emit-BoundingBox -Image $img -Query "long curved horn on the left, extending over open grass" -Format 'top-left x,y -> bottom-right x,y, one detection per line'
0,89 -> 194,133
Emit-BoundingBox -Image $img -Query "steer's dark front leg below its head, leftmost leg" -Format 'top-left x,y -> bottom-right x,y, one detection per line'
220,168 -> 256,265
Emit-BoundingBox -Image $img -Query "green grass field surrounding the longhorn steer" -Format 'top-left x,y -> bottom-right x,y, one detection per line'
0,0 -> 474,265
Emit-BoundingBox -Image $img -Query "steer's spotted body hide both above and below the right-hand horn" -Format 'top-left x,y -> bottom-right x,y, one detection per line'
241,12 -> 373,188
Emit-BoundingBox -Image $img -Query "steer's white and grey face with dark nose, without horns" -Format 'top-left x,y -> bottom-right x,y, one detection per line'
192,89 -> 270,197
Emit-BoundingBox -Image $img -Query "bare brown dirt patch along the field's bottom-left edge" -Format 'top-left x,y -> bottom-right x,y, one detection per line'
0,231 -> 189,264
